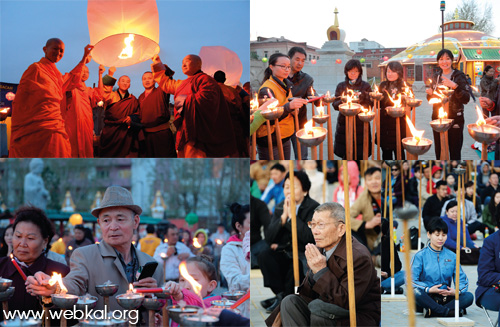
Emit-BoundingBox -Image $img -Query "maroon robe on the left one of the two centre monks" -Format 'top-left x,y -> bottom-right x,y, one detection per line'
99,95 -> 139,158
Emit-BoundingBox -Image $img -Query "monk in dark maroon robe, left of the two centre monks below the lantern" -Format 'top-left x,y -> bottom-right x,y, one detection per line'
99,71 -> 142,158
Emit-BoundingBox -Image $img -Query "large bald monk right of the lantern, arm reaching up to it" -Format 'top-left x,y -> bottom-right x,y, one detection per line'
152,54 -> 238,158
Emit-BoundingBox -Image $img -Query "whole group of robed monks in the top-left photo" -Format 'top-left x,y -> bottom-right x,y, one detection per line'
0,38 -> 250,158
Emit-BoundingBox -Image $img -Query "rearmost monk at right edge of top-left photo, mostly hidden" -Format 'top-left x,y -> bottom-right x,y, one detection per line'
214,70 -> 250,158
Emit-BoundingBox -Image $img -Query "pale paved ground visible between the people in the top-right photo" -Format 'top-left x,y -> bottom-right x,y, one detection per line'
282,92 -> 479,160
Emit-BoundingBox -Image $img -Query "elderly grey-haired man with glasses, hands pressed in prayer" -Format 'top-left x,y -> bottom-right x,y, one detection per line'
266,203 -> 380,326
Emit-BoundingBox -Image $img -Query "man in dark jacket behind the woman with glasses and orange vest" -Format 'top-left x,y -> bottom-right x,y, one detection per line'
288,47 -> 314,160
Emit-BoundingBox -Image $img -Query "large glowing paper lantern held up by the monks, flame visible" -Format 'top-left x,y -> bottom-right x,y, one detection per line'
87,0 -> 160,67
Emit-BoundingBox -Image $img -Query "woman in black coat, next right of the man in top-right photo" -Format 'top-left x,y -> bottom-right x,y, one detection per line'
333,59 -> 372,159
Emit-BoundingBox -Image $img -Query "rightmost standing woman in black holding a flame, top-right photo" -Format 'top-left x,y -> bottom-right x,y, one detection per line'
425,49 -> 470,160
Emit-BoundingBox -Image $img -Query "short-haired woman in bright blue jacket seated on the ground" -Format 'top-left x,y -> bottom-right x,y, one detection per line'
407,217 -> 474,318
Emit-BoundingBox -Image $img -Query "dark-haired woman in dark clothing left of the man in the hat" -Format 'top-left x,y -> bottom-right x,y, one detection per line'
0,207 -> 69,320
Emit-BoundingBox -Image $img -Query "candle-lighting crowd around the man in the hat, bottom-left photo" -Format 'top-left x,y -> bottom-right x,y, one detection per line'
0,186 -> 250,326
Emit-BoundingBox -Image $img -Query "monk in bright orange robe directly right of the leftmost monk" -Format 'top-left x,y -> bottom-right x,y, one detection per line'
61,65 -> 105,158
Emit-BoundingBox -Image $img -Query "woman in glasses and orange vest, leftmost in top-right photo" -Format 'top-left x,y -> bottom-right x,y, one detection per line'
256,53 -> 307,160
